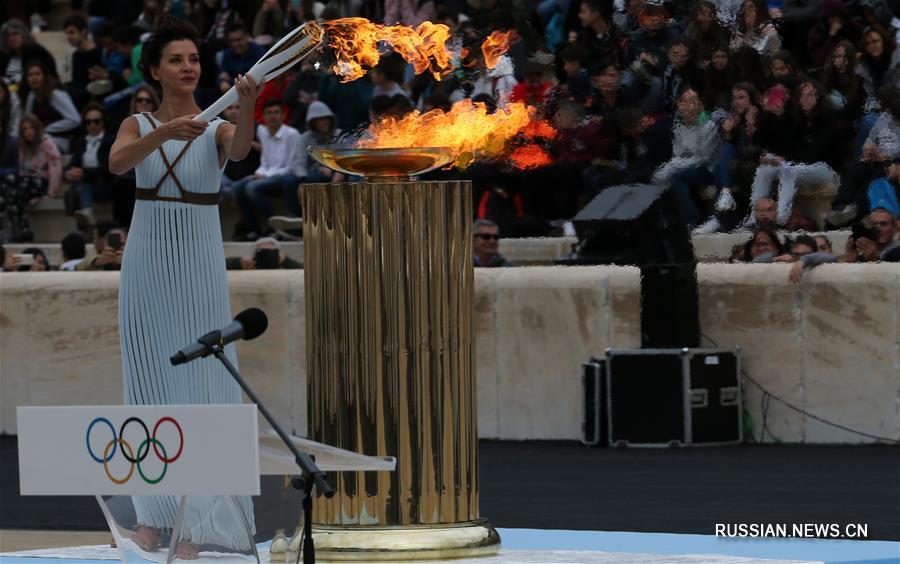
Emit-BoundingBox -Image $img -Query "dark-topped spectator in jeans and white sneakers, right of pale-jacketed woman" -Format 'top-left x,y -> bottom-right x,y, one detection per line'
694,82 -> 762,233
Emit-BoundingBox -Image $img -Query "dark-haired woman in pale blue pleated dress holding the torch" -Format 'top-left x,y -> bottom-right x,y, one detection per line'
109,19 -> 259,558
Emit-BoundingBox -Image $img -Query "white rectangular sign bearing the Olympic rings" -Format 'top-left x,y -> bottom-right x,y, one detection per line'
16,405 -> 259,495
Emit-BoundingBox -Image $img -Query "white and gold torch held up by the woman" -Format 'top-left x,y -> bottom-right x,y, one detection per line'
195,21 -> 325,122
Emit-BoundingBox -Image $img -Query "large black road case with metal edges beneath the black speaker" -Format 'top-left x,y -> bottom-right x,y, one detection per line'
605,348 -> 743,446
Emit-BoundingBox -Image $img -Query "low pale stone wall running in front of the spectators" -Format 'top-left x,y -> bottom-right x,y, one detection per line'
0,264 -> 900,443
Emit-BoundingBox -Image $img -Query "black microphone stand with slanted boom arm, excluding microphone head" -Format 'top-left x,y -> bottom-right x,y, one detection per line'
200,331 -> 334,564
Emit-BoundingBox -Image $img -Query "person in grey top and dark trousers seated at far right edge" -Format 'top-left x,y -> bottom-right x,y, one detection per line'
825,88 -> 900,227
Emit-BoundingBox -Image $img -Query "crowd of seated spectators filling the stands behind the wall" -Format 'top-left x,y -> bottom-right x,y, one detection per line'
0,0 -> 900,268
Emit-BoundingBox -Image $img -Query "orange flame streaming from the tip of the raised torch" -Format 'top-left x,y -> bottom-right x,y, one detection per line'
324,18 -> 515,82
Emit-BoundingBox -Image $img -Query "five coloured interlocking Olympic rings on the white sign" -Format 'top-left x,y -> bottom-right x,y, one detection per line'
85,417 -> 184,485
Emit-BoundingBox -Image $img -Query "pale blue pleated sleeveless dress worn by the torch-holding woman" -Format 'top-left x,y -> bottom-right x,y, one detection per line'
119,114 -> 255,549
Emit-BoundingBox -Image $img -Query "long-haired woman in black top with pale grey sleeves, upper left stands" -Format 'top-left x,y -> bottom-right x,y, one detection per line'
18,61 -> 81,153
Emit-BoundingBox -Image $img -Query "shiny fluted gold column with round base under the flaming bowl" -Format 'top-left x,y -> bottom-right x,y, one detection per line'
303,179 -> 499,560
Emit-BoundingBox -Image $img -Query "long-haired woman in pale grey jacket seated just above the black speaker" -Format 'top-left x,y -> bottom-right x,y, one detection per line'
653,88 -> 721,229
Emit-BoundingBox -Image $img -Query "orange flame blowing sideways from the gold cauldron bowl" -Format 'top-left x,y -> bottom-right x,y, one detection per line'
357,100 -> 555,168
